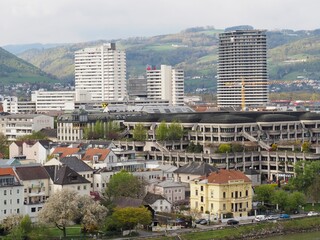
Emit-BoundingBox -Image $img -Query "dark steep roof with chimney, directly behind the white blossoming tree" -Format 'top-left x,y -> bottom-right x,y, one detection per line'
44,165 -> 90,185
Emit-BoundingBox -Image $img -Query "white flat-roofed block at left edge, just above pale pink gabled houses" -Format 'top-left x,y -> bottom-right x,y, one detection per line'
0,114 -> 54,141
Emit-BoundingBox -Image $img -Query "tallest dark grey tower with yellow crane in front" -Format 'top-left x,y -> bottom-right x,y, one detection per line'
217,30 -> 269,110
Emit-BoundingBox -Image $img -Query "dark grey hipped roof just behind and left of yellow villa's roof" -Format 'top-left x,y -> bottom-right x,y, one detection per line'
174,162 -> 218,176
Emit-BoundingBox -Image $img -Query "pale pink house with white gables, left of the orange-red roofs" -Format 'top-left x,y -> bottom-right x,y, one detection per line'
9,140 -> 51,165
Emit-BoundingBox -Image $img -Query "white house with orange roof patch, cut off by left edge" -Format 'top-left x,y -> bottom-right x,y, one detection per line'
0,167 -> 24,222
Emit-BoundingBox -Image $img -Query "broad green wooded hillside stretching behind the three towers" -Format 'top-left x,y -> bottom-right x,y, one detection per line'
12,27 -> 320,92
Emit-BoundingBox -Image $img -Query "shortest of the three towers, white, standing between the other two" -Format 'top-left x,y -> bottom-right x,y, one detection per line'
147,65 -> 184,106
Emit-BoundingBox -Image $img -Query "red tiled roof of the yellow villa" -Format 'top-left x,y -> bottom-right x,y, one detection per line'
203,169 -> 251,184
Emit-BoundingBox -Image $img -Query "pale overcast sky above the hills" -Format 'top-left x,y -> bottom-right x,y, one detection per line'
0,0 -> 320,46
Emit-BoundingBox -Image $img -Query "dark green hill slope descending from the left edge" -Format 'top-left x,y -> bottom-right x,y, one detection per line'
0,48 -> 58,85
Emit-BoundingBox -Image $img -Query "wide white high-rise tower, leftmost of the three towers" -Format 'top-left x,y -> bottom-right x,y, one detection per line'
75,43 -> 127,101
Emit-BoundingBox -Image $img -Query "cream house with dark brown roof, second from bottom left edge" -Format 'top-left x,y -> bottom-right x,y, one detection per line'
15,165 -> 49,221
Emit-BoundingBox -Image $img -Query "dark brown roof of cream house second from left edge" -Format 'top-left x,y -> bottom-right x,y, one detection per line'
15,166 -> 49,181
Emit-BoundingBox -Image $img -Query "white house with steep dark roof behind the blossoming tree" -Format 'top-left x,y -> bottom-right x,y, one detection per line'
44,165 -> 91,196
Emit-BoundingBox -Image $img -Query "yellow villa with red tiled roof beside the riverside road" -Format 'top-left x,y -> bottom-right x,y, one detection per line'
190,169 -> 252,219
